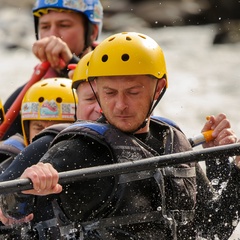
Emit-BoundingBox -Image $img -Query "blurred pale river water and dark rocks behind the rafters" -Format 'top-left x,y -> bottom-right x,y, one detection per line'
0,0 -> 240,237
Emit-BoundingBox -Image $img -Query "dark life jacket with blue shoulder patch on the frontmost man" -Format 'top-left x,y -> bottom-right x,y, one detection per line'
35,117 -> 196,239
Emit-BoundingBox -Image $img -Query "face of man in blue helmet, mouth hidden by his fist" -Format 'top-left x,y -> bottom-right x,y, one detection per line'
39,11 -> 85,55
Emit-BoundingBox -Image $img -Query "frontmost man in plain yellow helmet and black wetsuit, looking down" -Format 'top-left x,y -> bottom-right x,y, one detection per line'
1,32 -> 240,240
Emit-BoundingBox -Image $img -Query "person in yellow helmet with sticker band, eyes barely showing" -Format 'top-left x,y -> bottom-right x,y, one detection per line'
0,78 -> 77,171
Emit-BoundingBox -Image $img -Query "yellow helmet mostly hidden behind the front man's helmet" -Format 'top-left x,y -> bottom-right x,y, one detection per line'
72,51 -> 93,89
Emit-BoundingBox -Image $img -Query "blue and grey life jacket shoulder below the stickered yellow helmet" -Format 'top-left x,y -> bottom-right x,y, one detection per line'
0,133 -> 25,172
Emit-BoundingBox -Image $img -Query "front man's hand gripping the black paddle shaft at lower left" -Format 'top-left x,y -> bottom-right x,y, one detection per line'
20,162 -> 62,196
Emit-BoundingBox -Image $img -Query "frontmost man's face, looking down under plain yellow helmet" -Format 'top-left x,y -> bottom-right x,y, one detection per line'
96,76 -> 157,132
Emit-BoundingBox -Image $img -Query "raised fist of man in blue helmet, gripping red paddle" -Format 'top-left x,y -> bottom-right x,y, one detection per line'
32,36 -> 73,70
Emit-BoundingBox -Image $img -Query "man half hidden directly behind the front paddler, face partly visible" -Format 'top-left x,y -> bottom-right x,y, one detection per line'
0,52 -> 100,240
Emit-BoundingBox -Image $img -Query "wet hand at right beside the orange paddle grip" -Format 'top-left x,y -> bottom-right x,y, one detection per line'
202,113 -> 237,148
